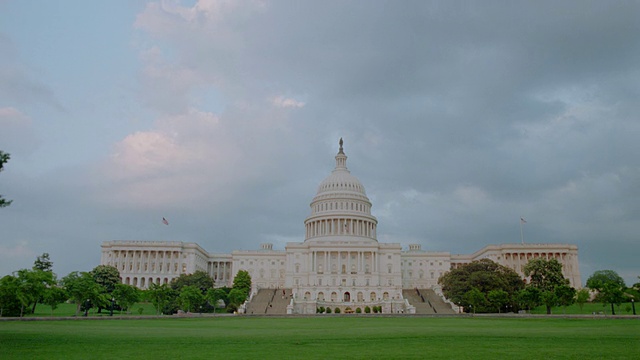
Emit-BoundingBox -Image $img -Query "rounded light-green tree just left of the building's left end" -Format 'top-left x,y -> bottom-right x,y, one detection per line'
61,271 -> 106,316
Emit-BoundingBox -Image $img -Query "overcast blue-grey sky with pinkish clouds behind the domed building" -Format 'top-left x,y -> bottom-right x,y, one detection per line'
0,0 -> 640,285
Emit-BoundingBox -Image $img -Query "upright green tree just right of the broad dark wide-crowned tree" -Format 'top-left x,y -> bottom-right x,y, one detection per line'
524,258 -> 569,314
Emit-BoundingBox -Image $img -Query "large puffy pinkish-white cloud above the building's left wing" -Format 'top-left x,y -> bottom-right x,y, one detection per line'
100,109 -> 241,207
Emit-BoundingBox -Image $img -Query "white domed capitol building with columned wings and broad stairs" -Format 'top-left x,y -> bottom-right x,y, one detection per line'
101,139 -> 581,314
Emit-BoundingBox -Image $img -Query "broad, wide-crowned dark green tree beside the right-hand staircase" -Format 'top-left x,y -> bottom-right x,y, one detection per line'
438,259 -> 524,312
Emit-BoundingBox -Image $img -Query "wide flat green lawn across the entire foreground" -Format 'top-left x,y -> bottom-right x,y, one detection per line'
0,315 -> 640,360
